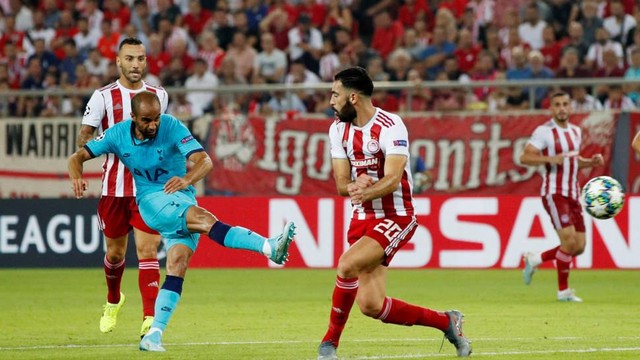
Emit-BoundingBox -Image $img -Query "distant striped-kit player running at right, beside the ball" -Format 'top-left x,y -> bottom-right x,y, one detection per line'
520,92 -> 604,302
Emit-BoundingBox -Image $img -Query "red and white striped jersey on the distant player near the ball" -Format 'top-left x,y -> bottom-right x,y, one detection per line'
529,119 -> 582,199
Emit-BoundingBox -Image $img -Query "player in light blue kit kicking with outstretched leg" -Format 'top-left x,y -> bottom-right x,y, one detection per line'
69,92 -> 295,351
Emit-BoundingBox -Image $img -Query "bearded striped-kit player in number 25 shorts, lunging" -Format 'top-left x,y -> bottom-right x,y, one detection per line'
318,67 -> 471,360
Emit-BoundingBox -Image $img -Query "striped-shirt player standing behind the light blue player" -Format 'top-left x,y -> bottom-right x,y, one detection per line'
78,38 -> 169,336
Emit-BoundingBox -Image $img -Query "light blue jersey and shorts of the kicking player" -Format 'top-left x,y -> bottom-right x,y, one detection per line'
85,114 -> 204,250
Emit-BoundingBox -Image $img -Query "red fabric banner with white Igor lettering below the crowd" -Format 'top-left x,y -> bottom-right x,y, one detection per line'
207,112 -> 617,196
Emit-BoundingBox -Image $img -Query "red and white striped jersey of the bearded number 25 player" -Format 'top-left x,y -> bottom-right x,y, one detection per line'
329,108 -> 414,220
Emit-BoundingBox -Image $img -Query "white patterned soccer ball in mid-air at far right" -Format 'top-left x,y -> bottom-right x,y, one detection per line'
582,176 -> 624,219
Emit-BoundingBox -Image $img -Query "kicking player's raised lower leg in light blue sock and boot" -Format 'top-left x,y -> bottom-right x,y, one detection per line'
209,221 -> 296,265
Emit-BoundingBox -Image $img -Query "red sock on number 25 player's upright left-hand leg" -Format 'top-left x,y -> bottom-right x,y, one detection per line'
322,276 -> 358,347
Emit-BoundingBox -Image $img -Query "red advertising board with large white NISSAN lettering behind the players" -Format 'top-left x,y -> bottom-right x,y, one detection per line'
191,195 -> 640,269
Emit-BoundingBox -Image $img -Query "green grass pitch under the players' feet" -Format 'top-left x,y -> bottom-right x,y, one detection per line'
0,268 -> 640,360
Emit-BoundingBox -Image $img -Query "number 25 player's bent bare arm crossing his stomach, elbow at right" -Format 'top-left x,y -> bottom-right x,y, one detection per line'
349,155 -> 408,204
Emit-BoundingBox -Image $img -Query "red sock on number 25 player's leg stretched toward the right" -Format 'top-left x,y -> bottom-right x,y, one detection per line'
376,297 -> 449,331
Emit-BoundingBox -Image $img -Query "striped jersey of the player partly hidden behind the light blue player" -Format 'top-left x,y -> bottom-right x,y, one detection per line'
82,81 -> 169,197
